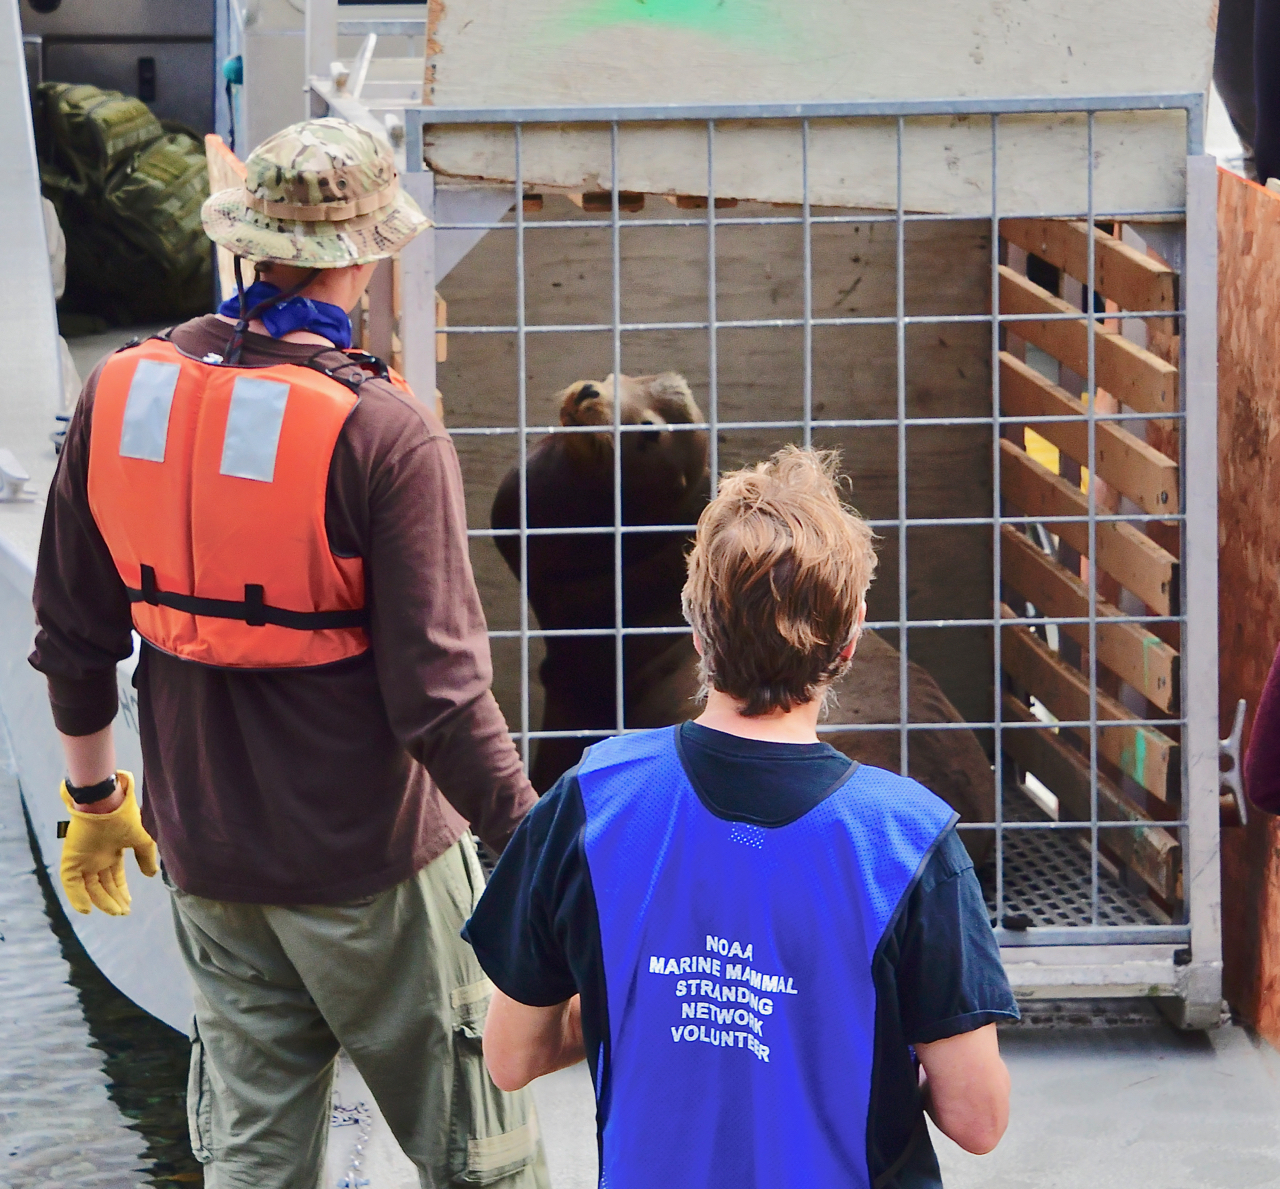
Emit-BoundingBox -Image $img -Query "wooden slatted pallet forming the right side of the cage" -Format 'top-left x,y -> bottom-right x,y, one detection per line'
998,219 -> 1181,905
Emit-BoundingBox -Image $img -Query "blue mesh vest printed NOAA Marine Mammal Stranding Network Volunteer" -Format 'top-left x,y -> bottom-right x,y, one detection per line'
579,727 -> 956,1189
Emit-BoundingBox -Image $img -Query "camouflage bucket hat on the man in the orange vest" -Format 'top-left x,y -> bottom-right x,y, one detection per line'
200,116 -> 431,269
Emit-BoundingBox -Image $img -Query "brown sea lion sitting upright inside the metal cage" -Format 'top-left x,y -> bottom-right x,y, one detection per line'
490,371 -> 995,864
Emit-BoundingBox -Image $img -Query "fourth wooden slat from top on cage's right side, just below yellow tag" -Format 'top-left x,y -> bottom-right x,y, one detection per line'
1000,442 -> 1178,616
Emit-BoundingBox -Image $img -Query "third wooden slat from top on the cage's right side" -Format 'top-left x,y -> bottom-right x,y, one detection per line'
1000,351 -> 1178,515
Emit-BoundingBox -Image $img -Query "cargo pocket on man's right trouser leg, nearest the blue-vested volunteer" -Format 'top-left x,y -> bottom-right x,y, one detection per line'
449,979 -> 540,1185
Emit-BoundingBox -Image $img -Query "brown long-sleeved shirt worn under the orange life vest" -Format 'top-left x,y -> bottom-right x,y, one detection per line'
31,316 -> 535,904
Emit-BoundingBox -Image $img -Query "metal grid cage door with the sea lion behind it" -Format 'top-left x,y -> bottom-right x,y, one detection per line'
406,95 -> 1221,1023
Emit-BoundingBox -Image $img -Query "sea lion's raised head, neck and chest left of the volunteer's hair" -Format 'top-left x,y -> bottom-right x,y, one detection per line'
492,371 -> 709,792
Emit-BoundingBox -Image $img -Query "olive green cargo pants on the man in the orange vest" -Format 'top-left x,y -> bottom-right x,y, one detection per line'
170,837 -> 549,1189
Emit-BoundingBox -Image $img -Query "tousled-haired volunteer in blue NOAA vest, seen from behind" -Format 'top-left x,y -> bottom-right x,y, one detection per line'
465,448 -> 1018,1189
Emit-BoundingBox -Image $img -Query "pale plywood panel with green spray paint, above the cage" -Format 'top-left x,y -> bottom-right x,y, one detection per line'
428,0 -> 1216,106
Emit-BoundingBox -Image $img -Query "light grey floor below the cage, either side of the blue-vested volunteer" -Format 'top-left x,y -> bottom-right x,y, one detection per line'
535,1005 -> 1280,1189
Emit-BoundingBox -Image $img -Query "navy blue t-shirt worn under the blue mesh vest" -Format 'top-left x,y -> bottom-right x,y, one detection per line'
463,722 -> 1018,1189
